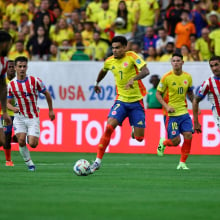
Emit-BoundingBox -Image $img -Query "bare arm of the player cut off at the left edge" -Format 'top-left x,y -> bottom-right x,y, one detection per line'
0,77 -> 12,125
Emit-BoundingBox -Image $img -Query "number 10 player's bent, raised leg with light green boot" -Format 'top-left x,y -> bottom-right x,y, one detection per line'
157,116 -> 181,156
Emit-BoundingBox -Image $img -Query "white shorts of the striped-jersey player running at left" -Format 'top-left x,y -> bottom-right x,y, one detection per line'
13,113 -> 40,137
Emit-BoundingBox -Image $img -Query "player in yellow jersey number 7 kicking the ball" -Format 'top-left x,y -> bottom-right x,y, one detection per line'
90,36 -> 149,173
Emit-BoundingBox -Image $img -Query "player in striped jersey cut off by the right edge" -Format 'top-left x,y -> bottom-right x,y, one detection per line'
193,56 -> 220,133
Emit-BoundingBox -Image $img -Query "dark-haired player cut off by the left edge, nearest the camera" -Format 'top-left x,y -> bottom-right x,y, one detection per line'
0,31 -> 12,163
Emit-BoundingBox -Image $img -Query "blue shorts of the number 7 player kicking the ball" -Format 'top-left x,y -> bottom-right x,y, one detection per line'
108,100 -> 145,128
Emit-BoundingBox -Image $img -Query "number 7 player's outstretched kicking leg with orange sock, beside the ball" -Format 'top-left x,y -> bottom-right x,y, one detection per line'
90,101 -> 126,173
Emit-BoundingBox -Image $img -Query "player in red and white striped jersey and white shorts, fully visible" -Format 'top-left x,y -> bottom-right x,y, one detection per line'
8,56 -> 55,171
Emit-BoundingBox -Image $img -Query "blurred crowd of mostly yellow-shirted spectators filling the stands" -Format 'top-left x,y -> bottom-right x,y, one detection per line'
0,0 -> 220,62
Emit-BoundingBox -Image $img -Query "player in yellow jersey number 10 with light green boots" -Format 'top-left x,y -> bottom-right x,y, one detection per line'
156,54 -> 194,170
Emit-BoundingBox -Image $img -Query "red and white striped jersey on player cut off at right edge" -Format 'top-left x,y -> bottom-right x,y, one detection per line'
197,76 -> 220,116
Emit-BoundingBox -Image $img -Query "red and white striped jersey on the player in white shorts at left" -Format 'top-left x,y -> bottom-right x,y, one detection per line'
8,76 -> 46,118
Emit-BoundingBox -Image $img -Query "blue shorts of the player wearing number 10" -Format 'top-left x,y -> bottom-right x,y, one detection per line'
165,113 -> 193,139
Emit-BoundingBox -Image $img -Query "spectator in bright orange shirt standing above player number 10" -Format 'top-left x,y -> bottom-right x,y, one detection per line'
175,10 -> 196,52
